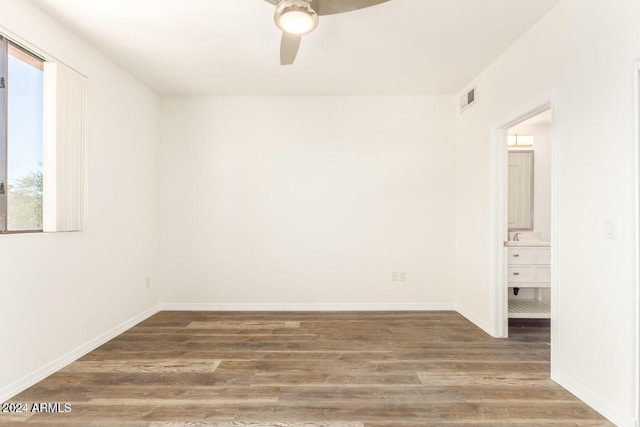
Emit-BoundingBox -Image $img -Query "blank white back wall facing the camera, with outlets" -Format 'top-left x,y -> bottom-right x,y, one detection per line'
161,97 -> 455,308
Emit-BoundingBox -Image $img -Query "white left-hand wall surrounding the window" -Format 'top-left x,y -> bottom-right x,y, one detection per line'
0,0 -> 159,401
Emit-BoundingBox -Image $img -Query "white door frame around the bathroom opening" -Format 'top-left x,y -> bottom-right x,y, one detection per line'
491,92 -> 560,373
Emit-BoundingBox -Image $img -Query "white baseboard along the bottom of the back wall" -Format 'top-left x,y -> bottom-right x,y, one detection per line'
160,303 -> 455,311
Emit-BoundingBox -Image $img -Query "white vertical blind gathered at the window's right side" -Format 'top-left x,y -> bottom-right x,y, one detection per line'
43,62 -> 87,232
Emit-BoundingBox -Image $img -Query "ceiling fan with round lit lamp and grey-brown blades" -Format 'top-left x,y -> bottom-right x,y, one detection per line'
265,0 -> 389,65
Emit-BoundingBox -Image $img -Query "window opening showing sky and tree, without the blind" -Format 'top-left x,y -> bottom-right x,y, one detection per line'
0,40 -> 44,232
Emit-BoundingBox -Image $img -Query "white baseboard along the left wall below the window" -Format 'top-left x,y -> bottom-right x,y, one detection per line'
0,305 -> 160,402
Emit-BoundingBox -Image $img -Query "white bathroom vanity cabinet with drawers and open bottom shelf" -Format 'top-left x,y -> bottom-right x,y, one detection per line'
507,245 -> 551,319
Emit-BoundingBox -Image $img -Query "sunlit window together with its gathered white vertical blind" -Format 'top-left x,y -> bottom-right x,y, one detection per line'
0,35 -> 87,233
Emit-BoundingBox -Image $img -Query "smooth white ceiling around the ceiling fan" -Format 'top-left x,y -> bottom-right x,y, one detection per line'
31,0 -> 560,95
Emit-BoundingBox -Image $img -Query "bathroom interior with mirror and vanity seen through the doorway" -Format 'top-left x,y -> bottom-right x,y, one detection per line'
505,109 -> 552,327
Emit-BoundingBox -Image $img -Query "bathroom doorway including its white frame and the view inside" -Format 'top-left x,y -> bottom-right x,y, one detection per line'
492,101 -> 558,362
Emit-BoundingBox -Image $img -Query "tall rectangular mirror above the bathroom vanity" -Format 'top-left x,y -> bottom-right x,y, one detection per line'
508,150 -> 533,231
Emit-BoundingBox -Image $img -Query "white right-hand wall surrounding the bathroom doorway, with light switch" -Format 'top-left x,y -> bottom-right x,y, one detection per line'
456,0 -> 640,426
